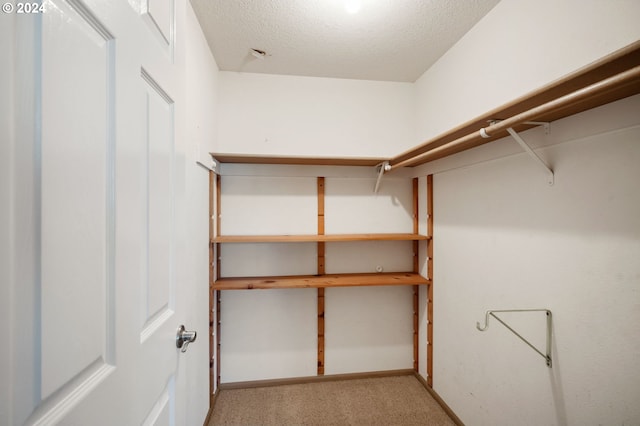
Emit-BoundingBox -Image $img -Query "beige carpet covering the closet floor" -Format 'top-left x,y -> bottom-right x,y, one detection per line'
209,376 -> 455,426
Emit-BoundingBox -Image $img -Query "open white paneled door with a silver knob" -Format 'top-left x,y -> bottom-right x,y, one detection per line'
0,0 -> 199,425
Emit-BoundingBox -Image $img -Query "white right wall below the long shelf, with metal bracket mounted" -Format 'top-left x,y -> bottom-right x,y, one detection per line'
420,96 -> 640,425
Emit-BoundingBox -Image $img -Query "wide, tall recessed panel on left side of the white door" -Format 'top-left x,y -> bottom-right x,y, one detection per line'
36,2 -> 115,400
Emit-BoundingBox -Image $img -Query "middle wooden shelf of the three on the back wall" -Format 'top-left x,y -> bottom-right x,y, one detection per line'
212,234 -> 430,243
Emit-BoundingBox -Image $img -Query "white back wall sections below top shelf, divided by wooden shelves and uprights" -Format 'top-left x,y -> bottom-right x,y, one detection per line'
220,170 -> 413,383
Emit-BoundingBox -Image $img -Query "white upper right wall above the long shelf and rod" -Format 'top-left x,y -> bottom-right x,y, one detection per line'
414,0 -> 640,144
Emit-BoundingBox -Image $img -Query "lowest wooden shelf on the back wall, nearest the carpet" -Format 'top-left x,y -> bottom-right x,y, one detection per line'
212,272 -> 431,290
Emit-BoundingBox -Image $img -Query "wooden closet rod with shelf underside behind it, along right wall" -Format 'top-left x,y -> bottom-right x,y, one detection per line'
391,65 -> 640,171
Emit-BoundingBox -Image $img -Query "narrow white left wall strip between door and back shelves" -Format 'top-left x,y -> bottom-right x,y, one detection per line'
179,2 -> 218,424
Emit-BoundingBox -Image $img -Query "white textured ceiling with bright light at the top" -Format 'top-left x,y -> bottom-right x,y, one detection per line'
191,0 -> 499,82
